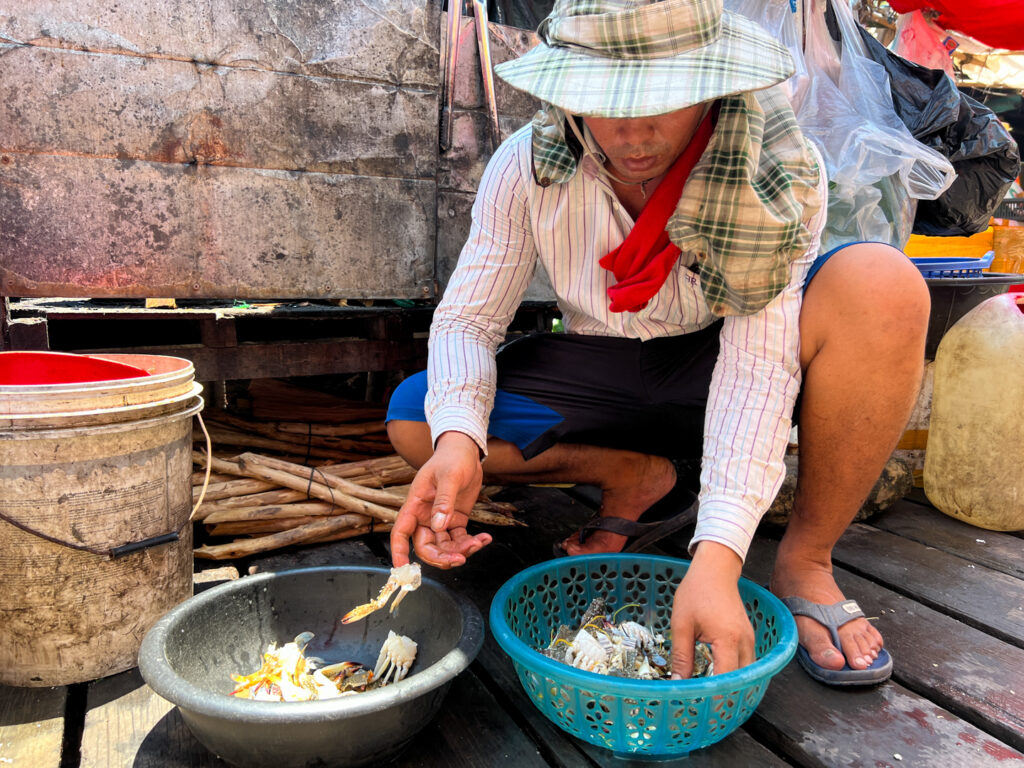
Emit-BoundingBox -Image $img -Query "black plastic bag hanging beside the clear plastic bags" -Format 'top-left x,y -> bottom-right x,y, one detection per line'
860,28 -> 1020,236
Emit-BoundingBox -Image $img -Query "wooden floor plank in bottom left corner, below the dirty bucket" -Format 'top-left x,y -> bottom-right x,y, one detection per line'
0,685 -> 68,768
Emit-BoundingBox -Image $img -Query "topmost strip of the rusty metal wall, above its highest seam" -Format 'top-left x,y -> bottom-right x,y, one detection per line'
0,0 -> 439,88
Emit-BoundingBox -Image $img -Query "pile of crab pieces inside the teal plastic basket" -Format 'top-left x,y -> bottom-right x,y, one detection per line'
541,597 -> 715,680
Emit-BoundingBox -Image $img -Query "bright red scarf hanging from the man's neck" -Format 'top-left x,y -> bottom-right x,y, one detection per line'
599,114 -> 714,312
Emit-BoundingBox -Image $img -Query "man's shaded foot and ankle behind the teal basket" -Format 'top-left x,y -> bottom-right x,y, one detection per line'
561,456 -> 676,555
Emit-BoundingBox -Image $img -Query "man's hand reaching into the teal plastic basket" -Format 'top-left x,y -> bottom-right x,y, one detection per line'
672,542 -> 755,680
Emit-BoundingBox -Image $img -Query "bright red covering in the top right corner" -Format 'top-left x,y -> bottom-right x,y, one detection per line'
889,0 -> 1024,50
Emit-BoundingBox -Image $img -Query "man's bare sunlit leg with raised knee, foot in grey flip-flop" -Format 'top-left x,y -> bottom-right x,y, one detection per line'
772,244 -> 930,670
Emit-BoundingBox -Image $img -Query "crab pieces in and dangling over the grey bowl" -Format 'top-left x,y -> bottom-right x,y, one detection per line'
231,563 -> 421,701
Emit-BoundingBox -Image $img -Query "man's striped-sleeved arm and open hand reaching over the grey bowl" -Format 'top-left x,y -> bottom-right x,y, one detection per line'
391,126 -> 537,568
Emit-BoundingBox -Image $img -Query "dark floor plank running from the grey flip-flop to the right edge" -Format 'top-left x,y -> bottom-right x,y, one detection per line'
743,537 -> 1024,750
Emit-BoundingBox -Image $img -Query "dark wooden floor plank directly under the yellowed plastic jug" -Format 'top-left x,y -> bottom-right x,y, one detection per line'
870,501 -> 1024,579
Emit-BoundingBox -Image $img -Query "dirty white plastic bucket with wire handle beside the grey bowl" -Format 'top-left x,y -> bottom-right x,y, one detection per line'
0,352 -> 203,686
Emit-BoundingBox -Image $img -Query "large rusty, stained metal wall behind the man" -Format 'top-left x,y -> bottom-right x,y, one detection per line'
0,0 -> 544,299
